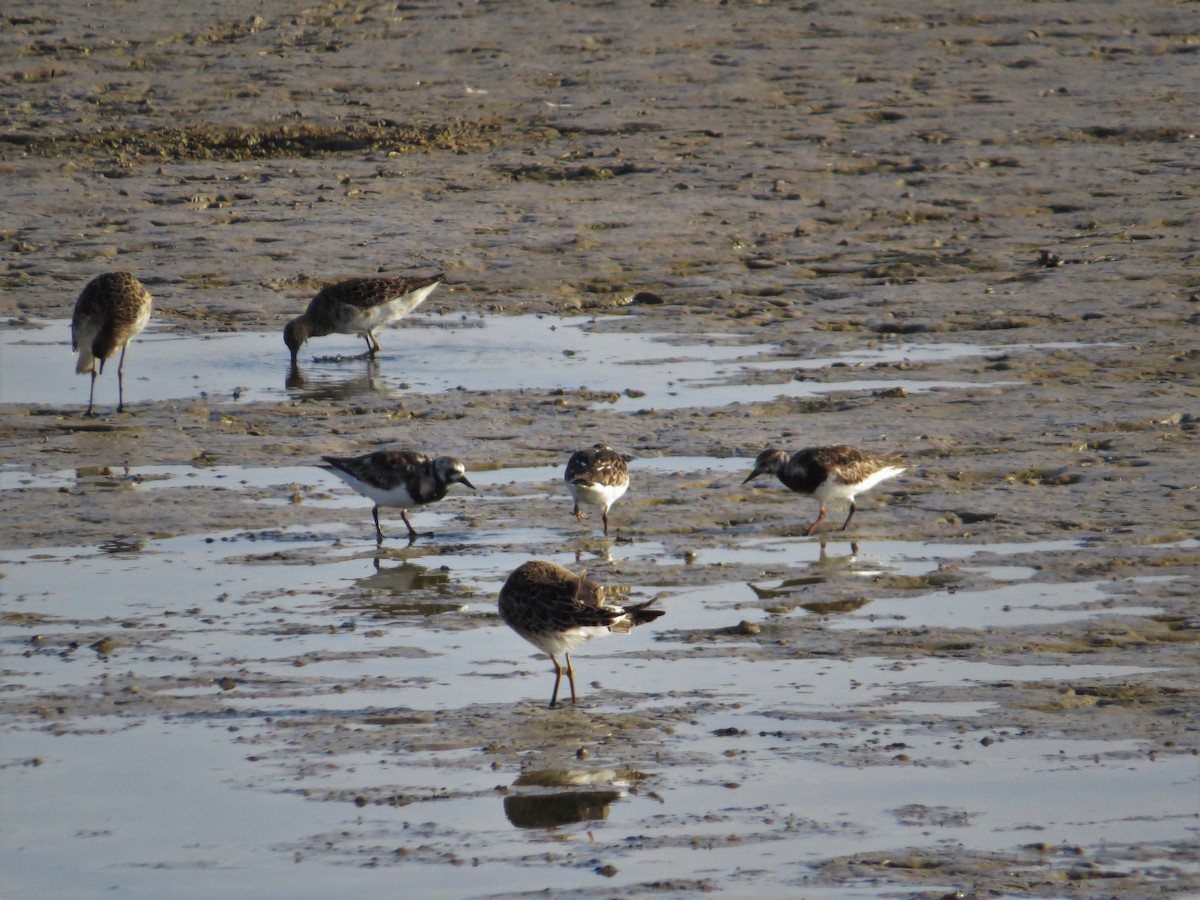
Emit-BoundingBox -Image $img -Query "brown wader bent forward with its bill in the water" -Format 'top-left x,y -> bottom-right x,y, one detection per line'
283,272 -> 445,368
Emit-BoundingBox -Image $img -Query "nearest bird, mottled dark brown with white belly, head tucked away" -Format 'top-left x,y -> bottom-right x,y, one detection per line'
500,559 -> 665,707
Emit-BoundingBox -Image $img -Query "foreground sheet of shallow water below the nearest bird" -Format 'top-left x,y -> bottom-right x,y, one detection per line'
6,720 -> 1189,898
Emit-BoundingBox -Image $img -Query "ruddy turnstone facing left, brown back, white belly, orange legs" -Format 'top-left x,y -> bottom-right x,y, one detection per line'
742,444 -> 905,534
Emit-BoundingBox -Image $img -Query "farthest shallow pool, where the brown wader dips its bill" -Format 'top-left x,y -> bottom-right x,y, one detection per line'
0,316 -> 1041,410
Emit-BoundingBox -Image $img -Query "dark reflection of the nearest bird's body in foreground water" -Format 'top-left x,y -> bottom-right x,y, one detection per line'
504,769 -> 644,828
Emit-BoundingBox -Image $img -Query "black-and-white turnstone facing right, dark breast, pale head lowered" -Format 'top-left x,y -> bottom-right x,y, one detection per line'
320,450 -> 475,544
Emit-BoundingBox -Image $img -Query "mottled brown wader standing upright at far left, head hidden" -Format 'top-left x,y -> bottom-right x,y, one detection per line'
71,272 -> 152,416
